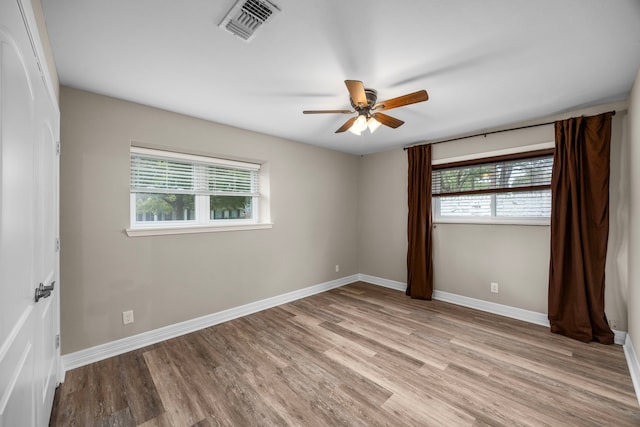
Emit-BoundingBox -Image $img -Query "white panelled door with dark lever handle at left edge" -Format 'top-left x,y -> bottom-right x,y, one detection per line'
0,0 -> 59,427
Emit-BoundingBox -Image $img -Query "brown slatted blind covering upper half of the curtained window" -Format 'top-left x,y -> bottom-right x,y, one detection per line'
432,149 -> 553,197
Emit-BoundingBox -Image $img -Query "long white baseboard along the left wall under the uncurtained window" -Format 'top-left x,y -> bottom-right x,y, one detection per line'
62,274 -> 359,372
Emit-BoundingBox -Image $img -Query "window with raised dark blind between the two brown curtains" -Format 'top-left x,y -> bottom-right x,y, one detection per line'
432,150 -> 553,222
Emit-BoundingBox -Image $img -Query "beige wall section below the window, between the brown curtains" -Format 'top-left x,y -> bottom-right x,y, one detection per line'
433,224 -> 549,313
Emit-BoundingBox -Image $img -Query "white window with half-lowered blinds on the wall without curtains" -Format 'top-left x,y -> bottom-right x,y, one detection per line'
128,147 -> 270,235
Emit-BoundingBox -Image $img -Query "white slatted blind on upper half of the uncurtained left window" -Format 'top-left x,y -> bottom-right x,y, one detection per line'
131,147 -> 260,197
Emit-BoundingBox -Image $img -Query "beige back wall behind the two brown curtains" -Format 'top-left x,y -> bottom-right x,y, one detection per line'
358,103 -> 629,330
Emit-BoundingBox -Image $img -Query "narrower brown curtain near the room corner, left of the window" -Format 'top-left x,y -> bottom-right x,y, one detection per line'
406,144 -> 433,300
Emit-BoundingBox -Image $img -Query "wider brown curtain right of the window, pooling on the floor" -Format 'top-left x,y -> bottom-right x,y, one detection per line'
549,113 -> 614,344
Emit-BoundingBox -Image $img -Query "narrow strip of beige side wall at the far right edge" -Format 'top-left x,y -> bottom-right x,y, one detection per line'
628,70 -> 640,355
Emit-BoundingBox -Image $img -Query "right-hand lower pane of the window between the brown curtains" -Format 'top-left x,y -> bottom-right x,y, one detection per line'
496,190 -> 551,218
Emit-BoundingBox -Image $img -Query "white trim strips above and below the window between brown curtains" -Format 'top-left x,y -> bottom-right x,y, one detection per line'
431,141 -> 555,227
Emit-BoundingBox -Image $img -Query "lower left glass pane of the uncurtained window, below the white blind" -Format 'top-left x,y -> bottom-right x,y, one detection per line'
136,193 -> 195,222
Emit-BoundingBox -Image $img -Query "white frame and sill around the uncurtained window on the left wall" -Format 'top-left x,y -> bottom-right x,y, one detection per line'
124,145 -> 273,237
